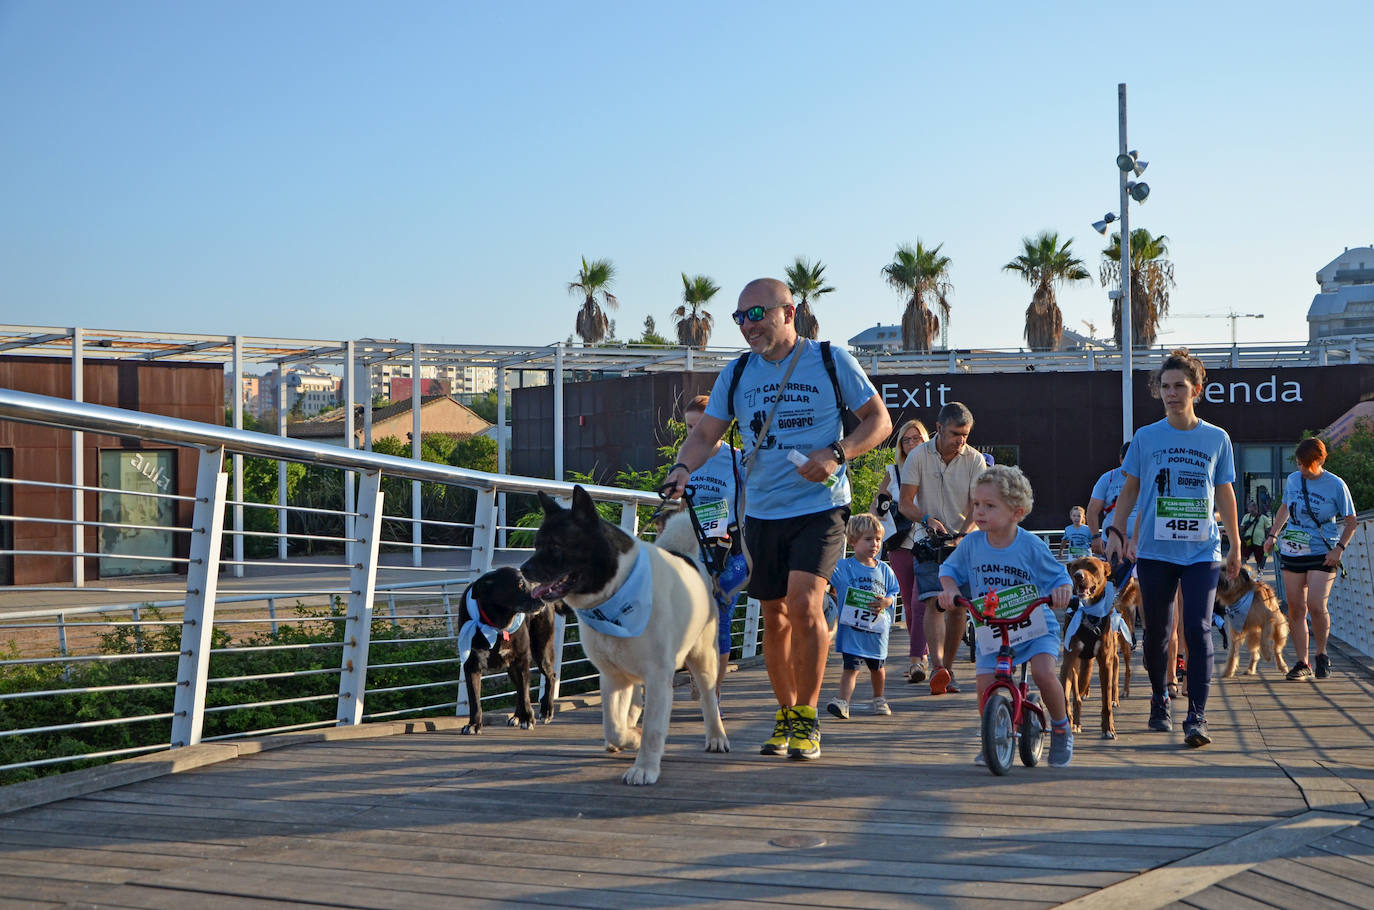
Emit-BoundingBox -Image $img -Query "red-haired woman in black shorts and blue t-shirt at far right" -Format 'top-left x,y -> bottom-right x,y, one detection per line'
1264,437 -> 1355,679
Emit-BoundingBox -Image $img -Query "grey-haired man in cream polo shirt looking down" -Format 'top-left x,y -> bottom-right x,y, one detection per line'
899,401 -> 988,696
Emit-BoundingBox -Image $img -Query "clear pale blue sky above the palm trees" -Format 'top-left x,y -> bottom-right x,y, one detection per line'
0,0 -> 1374,348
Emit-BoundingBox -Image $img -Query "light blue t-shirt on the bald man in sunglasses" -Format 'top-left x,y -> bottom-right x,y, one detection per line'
706,338 -> 878,518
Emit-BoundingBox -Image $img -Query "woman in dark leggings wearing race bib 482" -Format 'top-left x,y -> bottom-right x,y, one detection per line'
1107,348 -> 1241,748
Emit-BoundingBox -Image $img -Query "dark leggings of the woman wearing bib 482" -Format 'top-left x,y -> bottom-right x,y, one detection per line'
1136,559 -> 1221,715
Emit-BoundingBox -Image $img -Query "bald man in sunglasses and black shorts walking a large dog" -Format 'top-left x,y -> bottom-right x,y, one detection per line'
664,278 -> 892,760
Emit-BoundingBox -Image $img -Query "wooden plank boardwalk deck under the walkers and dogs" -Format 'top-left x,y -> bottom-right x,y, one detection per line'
0,637 -> 1374,910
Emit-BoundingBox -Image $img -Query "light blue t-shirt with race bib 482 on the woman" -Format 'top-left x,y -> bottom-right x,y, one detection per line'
1121,419 -> 1235,565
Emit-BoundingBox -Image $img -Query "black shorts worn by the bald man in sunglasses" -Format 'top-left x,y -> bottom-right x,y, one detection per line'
745,506 -> 849,601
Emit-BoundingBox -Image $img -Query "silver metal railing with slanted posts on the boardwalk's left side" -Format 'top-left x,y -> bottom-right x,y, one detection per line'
0,389 -> 758,775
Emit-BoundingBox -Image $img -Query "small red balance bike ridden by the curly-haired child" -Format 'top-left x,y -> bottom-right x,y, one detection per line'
958,592 -> 1050,777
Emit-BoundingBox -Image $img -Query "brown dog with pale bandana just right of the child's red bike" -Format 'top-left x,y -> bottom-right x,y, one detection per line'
1059,557 -> 1129,740
